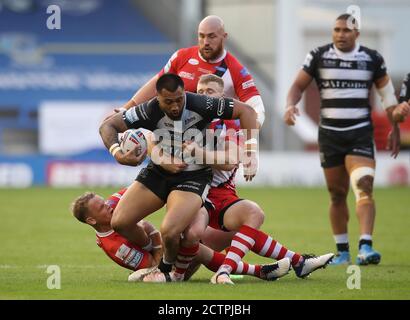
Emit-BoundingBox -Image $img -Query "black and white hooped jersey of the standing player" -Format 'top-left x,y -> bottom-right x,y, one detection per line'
302,44 -> 387,131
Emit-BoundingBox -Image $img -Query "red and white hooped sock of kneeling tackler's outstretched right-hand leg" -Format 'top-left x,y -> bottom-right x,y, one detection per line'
248,227 -> 303,266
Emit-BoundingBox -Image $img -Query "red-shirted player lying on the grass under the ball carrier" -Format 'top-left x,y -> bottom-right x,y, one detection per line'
72,189 -> 289,281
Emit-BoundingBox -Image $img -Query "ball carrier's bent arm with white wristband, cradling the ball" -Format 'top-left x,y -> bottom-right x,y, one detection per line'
99,112 -> 145,166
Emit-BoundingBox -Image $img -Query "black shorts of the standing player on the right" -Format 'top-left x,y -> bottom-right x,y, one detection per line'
319,126 -> 374,168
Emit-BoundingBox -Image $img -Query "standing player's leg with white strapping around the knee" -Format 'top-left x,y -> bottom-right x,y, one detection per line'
346,155 -> 381,265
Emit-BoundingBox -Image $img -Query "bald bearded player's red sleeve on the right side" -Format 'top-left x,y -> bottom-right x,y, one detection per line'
225,53 -> 260,102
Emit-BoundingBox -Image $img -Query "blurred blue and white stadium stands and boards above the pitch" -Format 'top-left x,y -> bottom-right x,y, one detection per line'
0,0 -> 410,187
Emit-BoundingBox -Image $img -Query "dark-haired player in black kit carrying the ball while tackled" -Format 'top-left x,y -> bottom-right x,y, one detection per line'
100,74 -> 258,278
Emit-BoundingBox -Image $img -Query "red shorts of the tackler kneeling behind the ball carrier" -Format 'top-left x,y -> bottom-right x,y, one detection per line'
205,187 -> 242,231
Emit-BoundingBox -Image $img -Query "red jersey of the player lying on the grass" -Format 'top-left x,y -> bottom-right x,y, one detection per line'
96,189 -> 151,271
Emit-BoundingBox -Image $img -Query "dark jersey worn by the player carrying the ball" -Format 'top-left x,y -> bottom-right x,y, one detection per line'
123,92 -> 234,171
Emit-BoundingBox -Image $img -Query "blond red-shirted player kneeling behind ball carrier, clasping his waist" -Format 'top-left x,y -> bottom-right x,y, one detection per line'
189,75 -> 333,284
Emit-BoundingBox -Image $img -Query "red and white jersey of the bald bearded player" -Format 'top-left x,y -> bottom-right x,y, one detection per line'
159,46 -> 260,102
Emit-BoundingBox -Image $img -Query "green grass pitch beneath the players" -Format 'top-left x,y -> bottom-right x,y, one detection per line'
0,188 -> 410,300
